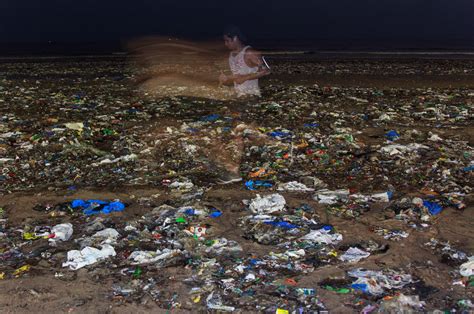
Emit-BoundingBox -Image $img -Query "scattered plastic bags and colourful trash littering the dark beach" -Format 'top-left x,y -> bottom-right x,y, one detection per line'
0,55 -> 474,313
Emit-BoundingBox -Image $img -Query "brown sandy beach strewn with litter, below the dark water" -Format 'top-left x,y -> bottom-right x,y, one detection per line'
0,54 -> 474,313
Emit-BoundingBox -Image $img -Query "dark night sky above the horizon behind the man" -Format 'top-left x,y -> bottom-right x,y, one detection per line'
0,0 -> 474,42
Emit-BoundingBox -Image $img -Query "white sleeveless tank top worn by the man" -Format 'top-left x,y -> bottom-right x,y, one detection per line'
229,46 -> 260,97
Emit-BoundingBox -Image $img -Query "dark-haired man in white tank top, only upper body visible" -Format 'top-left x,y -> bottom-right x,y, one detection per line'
219,26 -> 270,97
